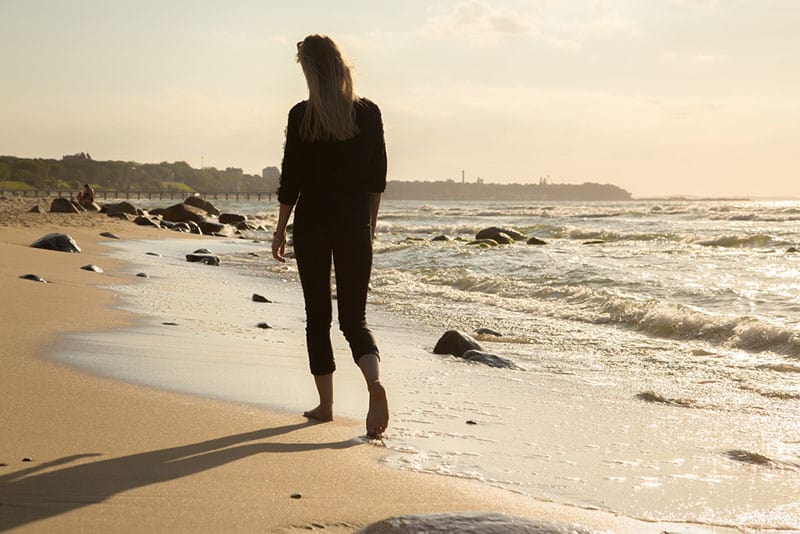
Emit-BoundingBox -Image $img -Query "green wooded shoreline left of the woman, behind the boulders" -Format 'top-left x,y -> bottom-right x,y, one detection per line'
0,153 -> 268,193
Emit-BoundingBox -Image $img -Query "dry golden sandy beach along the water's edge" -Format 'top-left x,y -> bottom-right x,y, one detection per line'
0,199 -> 736,532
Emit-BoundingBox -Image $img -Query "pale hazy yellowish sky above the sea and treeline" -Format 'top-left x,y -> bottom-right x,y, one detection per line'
0,0 -> 800,197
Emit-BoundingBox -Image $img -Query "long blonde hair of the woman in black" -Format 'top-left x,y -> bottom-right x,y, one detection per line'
297,35 -> 358,141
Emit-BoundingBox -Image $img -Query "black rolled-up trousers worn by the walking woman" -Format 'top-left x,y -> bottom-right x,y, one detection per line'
293,218 -> 379,375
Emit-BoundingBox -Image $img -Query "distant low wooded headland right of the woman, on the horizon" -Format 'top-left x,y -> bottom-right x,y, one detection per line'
385,180 -> 631,200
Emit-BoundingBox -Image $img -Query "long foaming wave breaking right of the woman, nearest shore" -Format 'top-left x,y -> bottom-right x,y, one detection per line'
373,268 -> 800,358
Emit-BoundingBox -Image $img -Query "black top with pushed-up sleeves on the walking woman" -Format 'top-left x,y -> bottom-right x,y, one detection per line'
278,98 -> 386,224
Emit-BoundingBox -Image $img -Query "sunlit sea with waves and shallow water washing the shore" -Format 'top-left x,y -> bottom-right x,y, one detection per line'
56,200 -> 800,532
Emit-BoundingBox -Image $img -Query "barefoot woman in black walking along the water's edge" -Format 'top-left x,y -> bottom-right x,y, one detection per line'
272,35 -> 389,437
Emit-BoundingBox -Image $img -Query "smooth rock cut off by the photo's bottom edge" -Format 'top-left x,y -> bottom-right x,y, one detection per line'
356,512 -> 594,534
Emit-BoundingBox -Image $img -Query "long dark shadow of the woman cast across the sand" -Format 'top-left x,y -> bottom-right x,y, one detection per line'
0,422 -> 362,530
